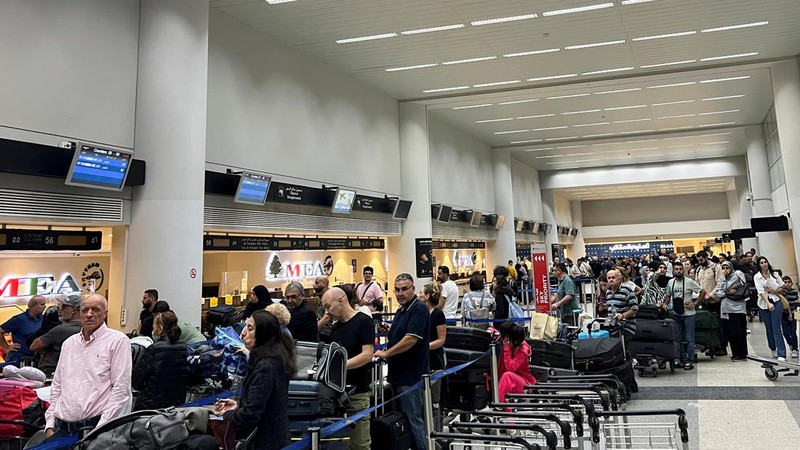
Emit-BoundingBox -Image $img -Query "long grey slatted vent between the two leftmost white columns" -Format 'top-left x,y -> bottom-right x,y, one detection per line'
203,206 -> 400,236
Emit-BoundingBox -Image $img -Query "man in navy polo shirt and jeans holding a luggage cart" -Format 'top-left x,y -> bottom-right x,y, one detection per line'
375,273 -> 431,450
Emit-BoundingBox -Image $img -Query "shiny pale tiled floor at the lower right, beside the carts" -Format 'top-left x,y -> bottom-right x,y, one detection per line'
628,319 -> 800,450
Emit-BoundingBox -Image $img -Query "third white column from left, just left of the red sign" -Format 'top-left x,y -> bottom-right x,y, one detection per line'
486,149 -> 517,275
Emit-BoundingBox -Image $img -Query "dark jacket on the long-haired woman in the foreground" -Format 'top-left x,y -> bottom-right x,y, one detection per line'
223,357 -> 289,450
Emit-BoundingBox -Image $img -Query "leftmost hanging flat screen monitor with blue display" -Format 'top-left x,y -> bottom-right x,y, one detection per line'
65,144 -> 133,191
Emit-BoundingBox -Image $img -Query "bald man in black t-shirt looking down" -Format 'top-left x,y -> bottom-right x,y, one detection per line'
322,287 -> 375,450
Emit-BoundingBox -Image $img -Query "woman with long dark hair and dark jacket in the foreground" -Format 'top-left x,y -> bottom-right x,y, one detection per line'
215,310 -> 297,450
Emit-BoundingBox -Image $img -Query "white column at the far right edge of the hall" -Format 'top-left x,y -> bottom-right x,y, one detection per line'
770,58 -> 800,280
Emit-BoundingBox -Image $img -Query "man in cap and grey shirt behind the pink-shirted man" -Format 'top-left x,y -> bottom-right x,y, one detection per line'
31,295 -> 81,378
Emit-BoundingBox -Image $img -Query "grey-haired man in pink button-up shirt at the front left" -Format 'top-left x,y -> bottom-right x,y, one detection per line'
45,294 -> 131,437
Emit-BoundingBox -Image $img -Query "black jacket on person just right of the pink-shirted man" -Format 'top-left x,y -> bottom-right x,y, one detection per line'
131,341 -> 189,411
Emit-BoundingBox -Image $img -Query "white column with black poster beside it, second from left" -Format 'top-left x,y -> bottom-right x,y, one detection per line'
388,103 -> 436,289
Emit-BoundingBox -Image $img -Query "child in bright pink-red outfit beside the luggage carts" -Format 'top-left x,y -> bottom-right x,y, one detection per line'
498,322 -> 536,402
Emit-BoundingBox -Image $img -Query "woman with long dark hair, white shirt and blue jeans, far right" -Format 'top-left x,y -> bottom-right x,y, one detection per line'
753,256 -> 786,361
